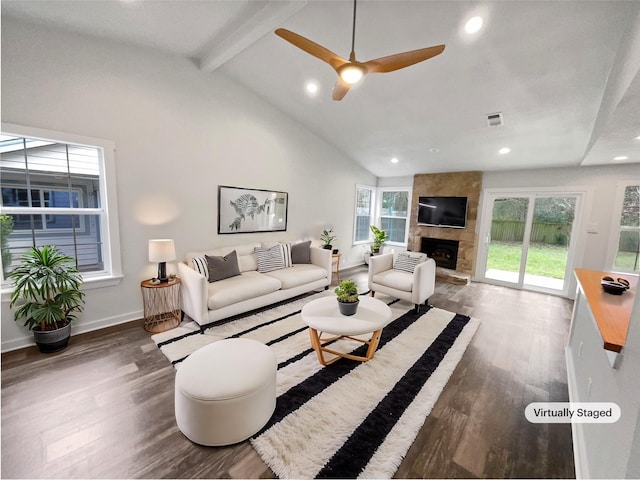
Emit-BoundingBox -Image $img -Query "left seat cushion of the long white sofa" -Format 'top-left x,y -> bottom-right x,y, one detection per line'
207,272 -> 280,310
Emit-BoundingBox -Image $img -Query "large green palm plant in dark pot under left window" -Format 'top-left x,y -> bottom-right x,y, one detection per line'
7,245 -> 84,353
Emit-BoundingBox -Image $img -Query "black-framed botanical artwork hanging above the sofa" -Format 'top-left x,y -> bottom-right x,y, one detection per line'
218,185 -> 289,234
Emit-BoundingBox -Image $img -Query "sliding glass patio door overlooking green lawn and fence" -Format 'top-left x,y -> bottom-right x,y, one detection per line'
479,192 -> 580,295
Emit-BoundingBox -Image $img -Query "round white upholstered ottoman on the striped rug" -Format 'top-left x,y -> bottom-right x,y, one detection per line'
175,338 -> 277,446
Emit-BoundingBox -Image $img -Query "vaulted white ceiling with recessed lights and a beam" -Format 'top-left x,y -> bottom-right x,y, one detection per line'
2,0 -> 640,177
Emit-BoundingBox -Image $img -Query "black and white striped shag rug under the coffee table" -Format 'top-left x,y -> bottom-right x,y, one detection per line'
152,291 -> 479,478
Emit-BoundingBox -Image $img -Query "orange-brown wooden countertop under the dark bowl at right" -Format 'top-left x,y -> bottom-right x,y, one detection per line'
575,268 -> 638,353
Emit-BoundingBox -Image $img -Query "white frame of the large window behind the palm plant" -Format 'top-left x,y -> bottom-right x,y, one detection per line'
2,123 -> 123,288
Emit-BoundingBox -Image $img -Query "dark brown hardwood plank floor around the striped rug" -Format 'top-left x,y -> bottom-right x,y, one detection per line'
1,268 -> 574,478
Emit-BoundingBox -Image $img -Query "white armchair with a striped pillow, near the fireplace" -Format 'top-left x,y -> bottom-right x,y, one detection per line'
369,253 -> 436,312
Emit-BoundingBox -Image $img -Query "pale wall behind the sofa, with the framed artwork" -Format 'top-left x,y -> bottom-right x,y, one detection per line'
2,16 -> 377,351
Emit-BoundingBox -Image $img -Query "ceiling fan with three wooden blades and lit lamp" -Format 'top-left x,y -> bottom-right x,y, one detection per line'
275,0 -> 444,100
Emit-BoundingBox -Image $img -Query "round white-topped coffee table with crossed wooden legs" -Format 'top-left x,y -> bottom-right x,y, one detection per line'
301,296 -> 391,365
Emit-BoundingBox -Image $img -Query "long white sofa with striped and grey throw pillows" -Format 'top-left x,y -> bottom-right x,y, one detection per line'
178,242 -> 332,330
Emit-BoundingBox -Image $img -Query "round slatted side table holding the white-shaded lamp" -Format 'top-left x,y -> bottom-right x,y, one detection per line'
140,277 -> 182,333
